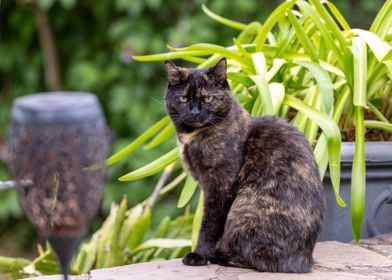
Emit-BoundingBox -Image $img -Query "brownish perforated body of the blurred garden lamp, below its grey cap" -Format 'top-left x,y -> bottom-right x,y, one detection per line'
10,122 -> 107,237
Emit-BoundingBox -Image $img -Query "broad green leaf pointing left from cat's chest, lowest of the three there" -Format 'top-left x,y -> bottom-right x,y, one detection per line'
118,148 -> 178,181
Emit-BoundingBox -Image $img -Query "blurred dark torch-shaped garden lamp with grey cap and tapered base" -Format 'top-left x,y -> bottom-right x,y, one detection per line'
9,92 -> 109,279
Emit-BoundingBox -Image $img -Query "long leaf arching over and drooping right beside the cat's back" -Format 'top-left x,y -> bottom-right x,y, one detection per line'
283,95 -> 346,207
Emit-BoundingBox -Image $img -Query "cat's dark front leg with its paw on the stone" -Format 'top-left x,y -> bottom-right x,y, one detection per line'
182,189 -> 232,266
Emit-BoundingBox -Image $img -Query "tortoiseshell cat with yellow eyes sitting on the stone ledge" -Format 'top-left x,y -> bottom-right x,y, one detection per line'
165,59 -> 325,273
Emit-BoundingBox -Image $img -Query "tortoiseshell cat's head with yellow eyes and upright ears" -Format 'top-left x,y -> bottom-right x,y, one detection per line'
165,59 -> 233,132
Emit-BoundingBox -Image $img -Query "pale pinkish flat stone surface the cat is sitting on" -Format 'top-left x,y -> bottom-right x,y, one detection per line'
23,233 -> 392,280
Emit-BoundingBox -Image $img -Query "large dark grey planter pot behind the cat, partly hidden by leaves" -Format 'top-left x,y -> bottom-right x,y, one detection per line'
319,142 -> 392,242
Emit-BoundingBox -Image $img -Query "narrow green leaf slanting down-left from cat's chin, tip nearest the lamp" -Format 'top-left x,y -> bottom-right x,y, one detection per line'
106,116 -> 170,165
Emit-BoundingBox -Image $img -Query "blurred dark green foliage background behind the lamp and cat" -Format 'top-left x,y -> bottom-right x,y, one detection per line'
0,0 -> 384,258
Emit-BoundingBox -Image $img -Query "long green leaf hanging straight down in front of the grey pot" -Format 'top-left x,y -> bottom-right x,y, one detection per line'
350,106 -> 366,242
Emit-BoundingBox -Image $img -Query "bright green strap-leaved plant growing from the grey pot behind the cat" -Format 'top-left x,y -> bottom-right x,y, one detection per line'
108,0 -> 392,244
